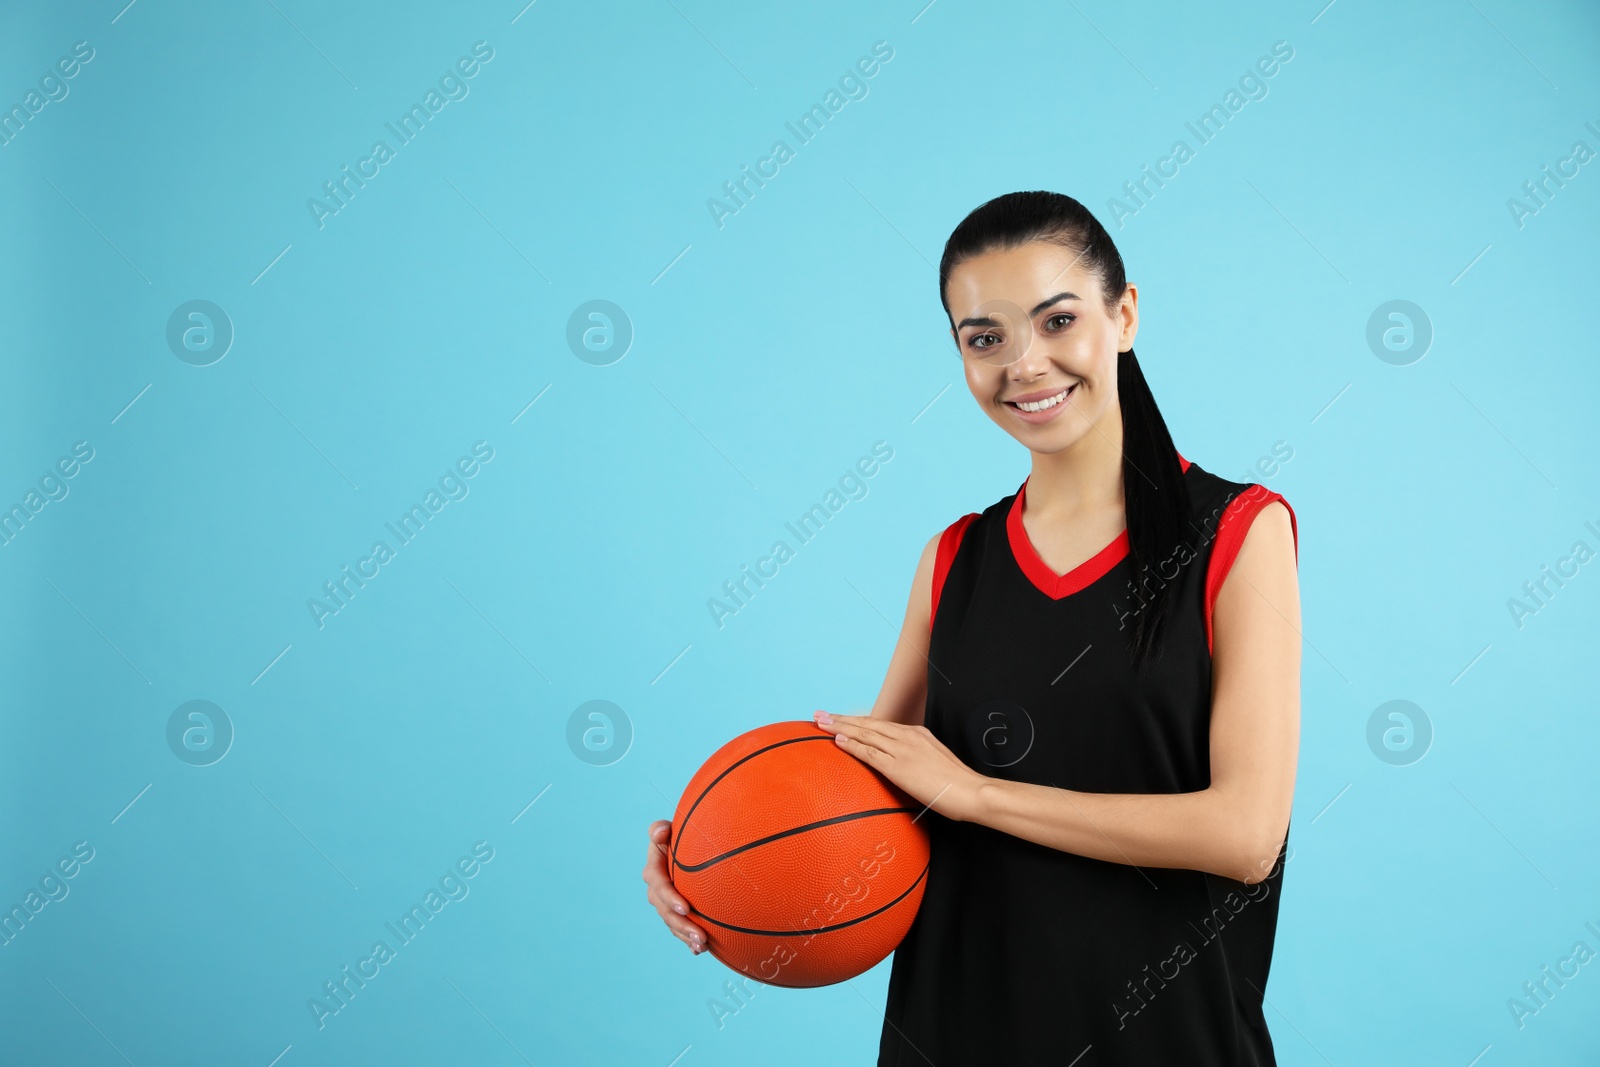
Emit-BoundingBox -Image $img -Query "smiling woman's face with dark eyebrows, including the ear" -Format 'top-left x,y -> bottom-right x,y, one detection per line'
946,242 -> 1139,453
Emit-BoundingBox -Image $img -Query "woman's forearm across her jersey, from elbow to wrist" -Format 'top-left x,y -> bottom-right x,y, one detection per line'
965,777 -> 1277,883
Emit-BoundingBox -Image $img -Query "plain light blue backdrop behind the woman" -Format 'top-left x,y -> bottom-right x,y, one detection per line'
0,0 -> 1600,1067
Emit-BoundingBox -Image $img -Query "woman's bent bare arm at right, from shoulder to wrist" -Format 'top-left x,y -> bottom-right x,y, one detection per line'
957,502 -> 1301,883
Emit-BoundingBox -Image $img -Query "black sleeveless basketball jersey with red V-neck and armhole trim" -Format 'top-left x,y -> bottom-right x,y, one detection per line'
878,456 -> 1298,1067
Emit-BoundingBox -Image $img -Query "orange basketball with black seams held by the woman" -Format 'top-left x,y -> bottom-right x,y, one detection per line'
669,720 -> 928,987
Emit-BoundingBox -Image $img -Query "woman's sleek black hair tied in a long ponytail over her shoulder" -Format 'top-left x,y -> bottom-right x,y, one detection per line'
939,190 -> 1190,662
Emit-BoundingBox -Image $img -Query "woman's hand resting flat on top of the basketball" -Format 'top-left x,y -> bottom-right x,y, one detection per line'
813,712 -> 989,822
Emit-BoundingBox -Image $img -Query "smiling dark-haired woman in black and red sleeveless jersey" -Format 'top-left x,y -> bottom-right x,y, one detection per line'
645,192 -> 1301,1067
